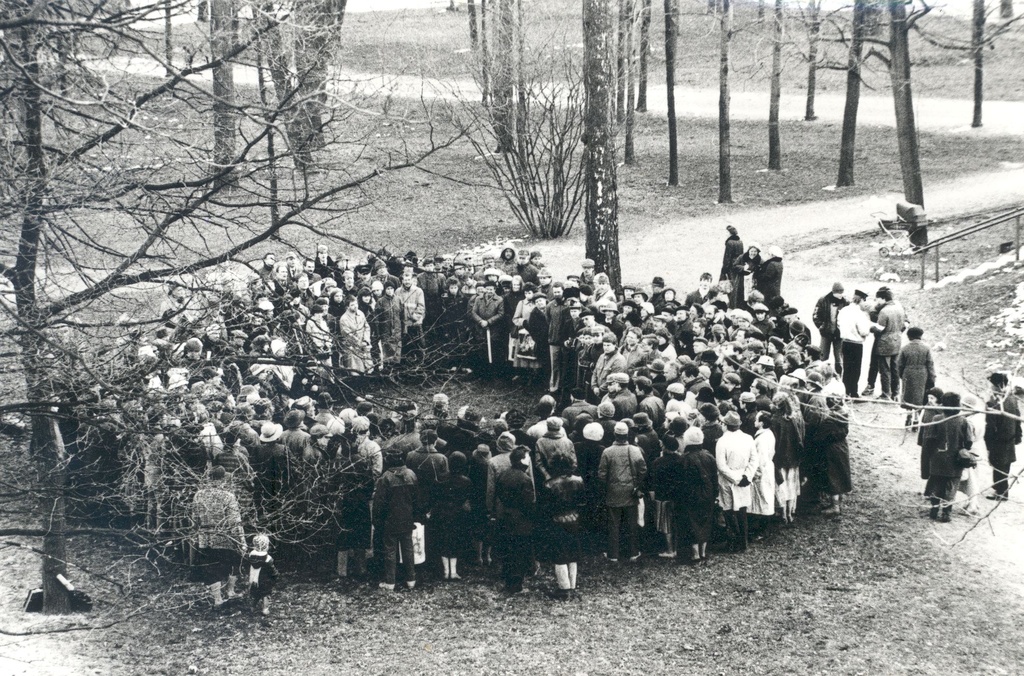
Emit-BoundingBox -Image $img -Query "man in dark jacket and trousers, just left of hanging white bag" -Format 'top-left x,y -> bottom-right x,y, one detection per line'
373,452 -> 416,591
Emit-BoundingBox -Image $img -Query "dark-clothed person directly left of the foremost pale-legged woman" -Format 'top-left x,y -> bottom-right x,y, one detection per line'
495,446 -> 537,594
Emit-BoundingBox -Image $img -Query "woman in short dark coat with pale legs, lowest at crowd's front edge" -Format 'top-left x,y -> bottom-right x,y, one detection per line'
536,455 -> 586,600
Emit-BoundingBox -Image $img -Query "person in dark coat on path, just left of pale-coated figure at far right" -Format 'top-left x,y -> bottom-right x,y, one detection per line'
925,392 -> 974,523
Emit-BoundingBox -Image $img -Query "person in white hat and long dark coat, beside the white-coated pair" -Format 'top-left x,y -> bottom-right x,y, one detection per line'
671,427 -> 718,563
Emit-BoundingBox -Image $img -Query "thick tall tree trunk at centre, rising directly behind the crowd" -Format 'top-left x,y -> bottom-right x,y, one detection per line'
583,0 -> 622,289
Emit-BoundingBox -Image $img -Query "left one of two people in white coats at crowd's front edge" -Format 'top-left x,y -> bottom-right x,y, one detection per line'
715,411 -> 758,552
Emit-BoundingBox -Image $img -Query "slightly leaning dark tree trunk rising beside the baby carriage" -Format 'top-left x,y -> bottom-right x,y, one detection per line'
889,0 -> 925,206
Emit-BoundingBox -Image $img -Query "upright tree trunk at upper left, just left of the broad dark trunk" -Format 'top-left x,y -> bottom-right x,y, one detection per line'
210,0 -> 238,179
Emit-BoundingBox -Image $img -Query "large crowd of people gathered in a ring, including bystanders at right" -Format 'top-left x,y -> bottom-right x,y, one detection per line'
94,227 -> 1021,611
